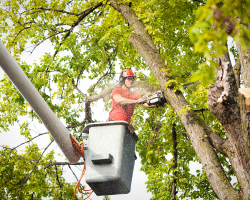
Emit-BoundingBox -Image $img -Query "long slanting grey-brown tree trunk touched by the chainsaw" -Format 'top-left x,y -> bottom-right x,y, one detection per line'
110,0 -> 240,200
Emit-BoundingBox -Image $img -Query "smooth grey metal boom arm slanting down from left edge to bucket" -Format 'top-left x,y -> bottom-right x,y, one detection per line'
0,41 -> 80,163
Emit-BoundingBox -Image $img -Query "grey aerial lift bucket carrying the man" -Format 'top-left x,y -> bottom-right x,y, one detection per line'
83,121 -> 138,196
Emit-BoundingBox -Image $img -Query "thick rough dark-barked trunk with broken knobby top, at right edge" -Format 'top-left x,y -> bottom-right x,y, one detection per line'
208,53 -> 250,199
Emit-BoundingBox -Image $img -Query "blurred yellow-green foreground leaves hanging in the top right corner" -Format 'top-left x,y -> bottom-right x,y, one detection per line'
189,0 -> 250,85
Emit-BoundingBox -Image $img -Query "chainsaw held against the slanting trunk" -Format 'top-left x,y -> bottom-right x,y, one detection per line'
137,91 -> 166,106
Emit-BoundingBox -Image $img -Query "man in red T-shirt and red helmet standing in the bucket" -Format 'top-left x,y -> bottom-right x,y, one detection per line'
107,69 -> 156,123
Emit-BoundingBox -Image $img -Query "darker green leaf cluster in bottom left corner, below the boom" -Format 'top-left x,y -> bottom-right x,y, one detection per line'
0,144 -> 74,199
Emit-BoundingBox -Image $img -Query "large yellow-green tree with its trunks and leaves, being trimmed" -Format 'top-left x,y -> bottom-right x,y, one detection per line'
0,0 -> 250,199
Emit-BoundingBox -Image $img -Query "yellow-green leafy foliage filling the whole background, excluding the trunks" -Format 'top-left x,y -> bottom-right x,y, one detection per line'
0,0 -> 247,199
